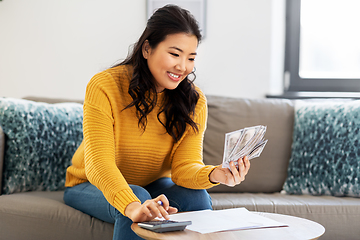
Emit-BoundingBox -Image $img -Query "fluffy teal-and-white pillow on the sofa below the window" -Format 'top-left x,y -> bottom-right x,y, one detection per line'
284,100 -> 360,197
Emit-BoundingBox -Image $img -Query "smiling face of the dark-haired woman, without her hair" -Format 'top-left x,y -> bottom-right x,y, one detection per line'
142,33 -> 198,92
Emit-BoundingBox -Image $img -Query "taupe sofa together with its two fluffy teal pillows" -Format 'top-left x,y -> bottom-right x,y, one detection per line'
0,96 -> 360,240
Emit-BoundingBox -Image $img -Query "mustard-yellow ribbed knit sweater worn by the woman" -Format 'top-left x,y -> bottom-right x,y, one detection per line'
65,66 -> 214,214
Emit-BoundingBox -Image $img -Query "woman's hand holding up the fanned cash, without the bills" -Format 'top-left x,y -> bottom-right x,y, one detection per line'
209,156 -> 250,187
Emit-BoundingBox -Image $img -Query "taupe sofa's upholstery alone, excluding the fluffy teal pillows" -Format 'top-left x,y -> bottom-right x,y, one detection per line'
0,96 -> 360,240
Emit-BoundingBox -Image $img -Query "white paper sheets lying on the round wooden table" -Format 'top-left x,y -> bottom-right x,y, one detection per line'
170,208 -> 287,234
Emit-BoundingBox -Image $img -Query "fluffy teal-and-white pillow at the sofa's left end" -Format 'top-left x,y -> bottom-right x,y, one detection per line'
0,98 -> 83,194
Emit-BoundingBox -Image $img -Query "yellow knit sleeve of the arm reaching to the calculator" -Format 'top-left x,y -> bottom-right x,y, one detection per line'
83,73 -> 140,214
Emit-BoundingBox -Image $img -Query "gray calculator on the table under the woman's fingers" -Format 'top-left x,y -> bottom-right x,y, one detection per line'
138,220 -> 191,233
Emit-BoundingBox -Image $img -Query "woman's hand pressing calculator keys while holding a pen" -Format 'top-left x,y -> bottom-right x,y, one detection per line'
125,194 -> 177,222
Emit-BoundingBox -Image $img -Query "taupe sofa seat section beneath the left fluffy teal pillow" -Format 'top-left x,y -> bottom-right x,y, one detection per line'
0,191 -> 114,240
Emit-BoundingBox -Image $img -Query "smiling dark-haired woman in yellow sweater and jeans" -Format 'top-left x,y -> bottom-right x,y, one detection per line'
64,5 -> 250,239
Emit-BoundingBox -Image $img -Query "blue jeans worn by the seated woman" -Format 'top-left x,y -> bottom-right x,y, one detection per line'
64,178 -> 212,240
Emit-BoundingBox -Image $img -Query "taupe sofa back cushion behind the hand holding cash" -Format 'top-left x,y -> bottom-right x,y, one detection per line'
204,96 -> 294,193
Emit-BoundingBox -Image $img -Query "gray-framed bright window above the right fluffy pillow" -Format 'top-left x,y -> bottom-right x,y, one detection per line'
285,0 -> 360,92
